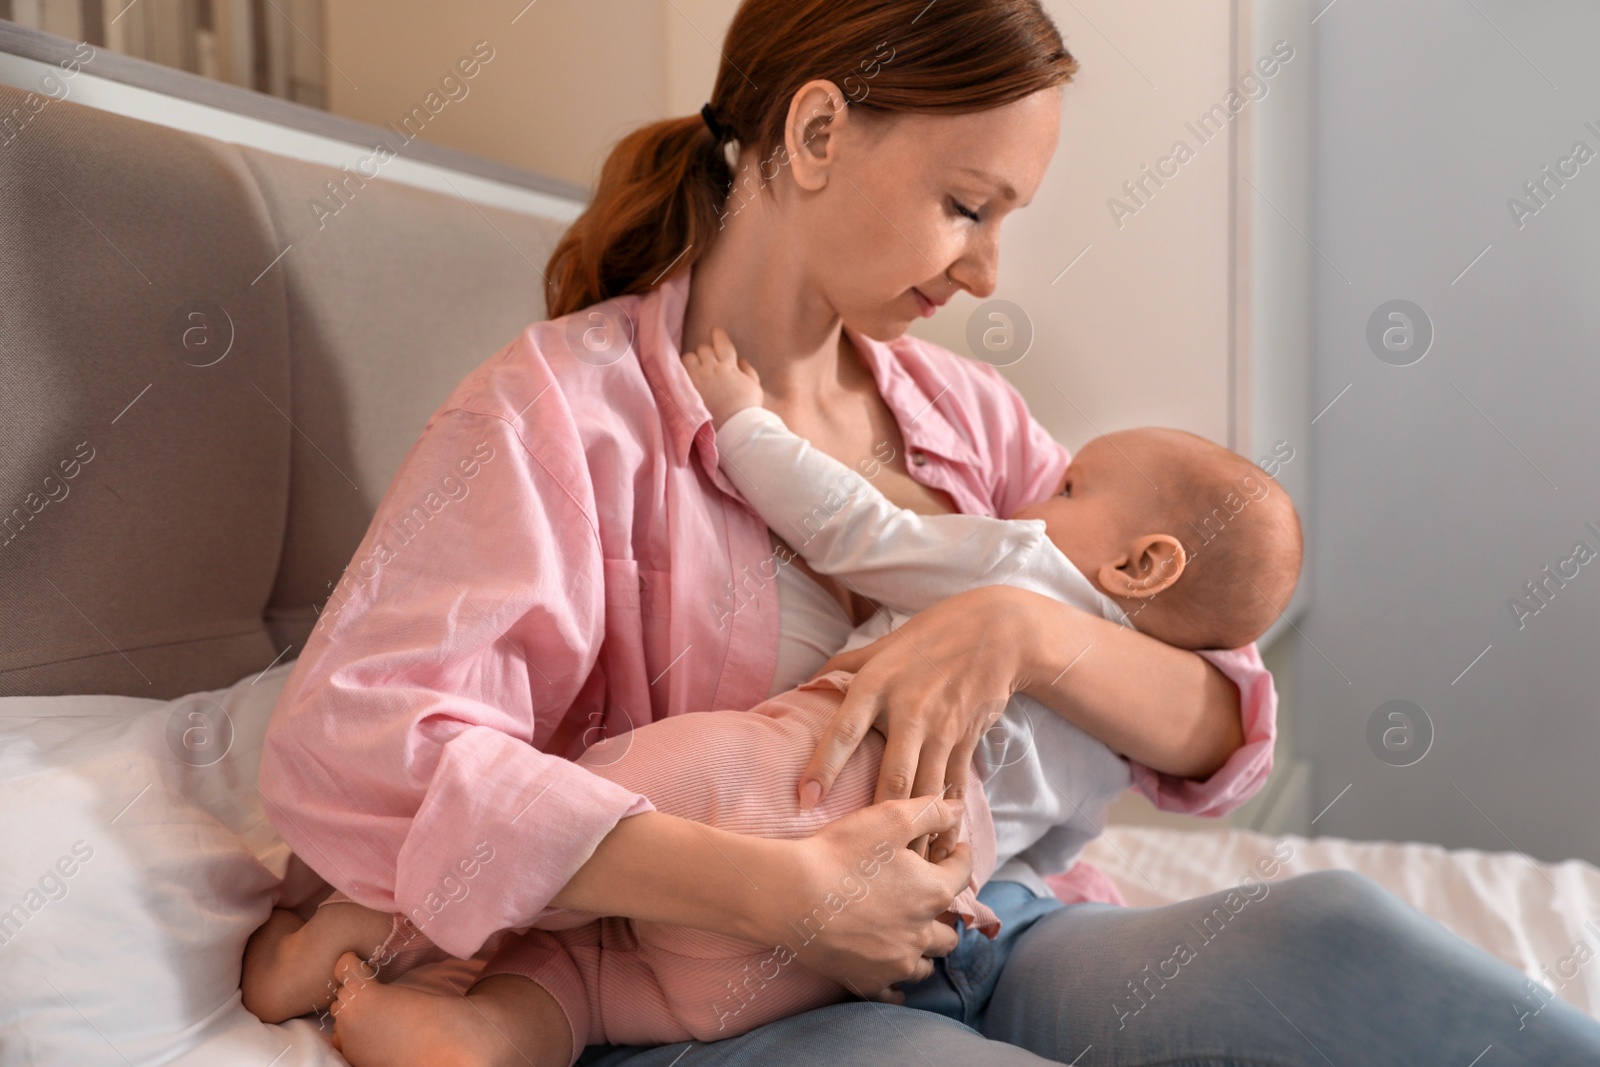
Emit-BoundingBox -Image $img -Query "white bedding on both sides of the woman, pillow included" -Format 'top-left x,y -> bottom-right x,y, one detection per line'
0,652 -> 1600,1067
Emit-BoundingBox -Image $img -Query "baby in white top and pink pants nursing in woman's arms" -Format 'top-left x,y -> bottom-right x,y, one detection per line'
243,330 -> 1301,1067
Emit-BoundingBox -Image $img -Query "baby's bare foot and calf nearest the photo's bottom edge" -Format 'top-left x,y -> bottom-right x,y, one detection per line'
333,953 -> 573,1067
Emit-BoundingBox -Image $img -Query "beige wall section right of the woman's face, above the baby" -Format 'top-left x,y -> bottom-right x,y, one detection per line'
914,0 -> 1232,448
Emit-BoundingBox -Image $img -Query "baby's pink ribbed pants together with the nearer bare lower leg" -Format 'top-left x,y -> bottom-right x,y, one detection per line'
324,675 -> 994,1067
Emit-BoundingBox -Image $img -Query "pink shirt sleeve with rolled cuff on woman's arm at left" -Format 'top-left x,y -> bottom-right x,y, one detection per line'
261,365 -> 650,957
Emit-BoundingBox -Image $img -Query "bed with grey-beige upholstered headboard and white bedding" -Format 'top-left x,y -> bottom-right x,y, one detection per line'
0,20 -> 1600,1067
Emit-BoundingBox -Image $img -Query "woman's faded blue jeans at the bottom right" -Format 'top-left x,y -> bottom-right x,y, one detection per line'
579,870 -> 1600,1067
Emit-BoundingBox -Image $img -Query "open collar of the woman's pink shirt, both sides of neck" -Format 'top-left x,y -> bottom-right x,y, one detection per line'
637,267 -> 976,467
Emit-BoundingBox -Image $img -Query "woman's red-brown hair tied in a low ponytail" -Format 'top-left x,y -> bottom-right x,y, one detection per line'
544,0 -> 1078,318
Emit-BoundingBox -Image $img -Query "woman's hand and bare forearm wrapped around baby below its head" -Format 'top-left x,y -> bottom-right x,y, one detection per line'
800,585 -> 1245,808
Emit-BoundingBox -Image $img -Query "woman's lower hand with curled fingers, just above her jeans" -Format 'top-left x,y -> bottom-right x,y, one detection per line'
741,797 -> 973,1003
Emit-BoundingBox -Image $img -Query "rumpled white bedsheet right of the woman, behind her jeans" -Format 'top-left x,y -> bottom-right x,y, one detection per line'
1083,825 -> 1600,1017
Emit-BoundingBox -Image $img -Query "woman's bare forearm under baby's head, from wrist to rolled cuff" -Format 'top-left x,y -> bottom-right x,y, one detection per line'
1008,590 -> 1245,781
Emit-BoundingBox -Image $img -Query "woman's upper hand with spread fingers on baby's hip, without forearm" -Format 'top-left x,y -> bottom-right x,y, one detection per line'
800,585 -> 1049,808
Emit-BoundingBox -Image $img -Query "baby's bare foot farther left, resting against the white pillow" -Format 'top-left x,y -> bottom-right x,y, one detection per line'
240,904 -> 394,1022
